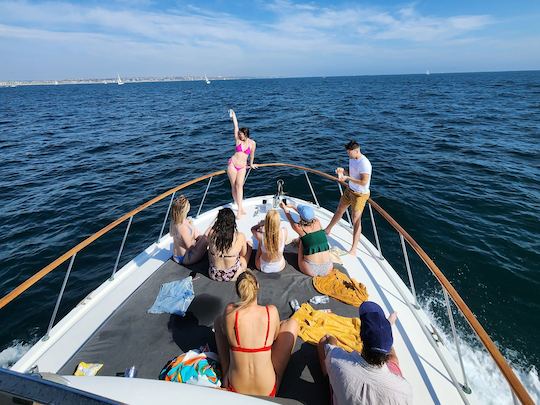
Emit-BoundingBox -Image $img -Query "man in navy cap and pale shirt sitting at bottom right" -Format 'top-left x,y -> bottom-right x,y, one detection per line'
318,301 -> 413,405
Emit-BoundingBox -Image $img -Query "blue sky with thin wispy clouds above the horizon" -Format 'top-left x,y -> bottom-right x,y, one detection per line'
0,0 -> 540,81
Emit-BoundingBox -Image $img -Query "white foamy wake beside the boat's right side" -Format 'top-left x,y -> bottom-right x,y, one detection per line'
421,297 -> 540,405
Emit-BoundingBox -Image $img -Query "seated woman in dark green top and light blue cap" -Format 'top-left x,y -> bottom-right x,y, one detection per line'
280,202 -> 334,277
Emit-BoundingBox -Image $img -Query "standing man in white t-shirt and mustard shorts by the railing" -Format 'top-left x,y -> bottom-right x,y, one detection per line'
325,141 -> 371,252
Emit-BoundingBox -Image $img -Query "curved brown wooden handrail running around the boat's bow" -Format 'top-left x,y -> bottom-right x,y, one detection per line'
0,163 -> 534,405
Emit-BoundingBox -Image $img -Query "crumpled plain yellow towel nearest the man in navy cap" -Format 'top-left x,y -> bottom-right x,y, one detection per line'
292,303 -> 362,352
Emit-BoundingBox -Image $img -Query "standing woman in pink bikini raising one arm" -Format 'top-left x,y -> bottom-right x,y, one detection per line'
227,110 -> 257,217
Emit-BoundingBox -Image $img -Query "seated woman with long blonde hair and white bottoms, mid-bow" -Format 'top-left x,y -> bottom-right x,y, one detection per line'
251,210 -> 287,273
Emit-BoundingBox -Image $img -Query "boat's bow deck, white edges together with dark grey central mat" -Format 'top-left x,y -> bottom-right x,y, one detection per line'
14,196 -> 476,404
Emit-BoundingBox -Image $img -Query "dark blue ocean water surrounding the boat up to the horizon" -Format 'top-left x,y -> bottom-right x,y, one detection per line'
0,71 -> 540,402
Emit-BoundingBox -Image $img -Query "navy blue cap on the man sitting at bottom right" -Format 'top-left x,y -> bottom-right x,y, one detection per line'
359,301 -> 394,354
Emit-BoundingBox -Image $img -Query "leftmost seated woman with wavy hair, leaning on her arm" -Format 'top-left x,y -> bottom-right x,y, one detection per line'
169,195 -> 208,265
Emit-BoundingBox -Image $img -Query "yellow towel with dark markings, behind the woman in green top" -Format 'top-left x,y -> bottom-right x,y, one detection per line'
313,269 -> 368,307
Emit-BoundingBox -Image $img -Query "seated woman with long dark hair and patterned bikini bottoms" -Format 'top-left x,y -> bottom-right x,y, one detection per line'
206,208 -> 251,281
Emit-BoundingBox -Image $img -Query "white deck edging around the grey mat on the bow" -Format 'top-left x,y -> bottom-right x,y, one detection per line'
13,196 -> 479,404
